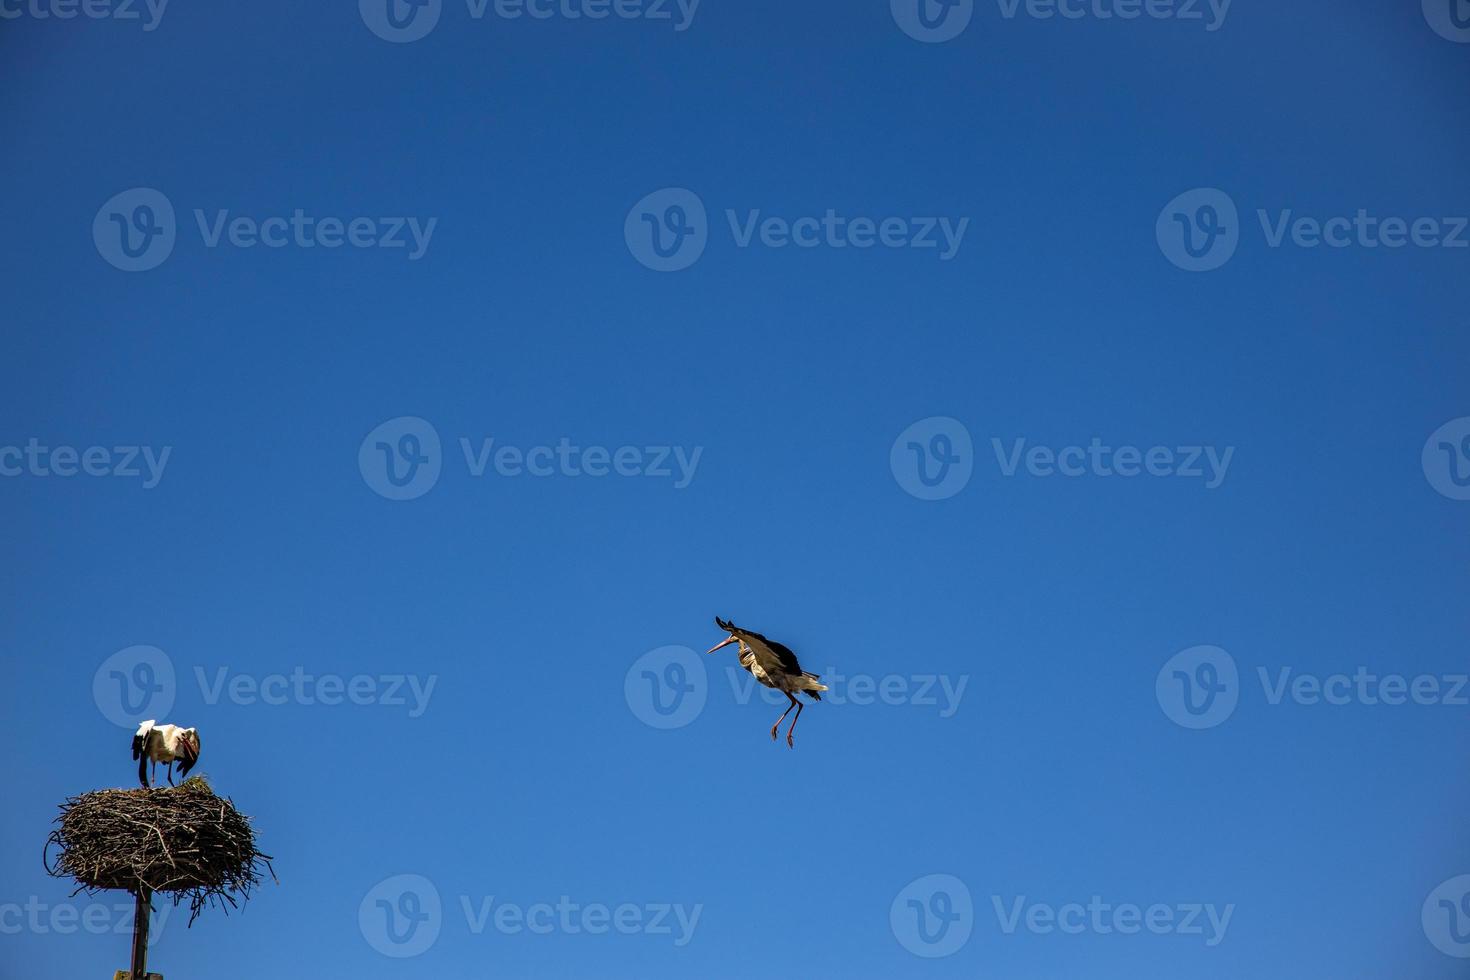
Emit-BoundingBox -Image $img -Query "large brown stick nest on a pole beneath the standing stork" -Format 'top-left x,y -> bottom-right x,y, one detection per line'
46,776 -> 275,924
